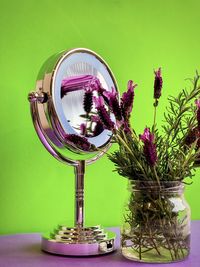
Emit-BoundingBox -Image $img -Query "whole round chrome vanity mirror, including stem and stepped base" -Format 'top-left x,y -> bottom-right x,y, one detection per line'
28,48 -> 117,255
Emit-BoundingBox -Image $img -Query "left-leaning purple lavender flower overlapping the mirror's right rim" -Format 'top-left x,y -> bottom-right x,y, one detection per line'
103,88 -> 122,121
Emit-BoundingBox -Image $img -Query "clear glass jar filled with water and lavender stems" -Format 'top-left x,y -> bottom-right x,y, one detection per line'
121,181 -> 190,263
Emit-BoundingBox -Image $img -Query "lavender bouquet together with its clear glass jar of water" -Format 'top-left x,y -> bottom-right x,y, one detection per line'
63,68 -> 200,262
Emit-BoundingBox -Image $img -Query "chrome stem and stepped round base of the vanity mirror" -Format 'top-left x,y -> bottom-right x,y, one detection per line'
42,160 -> 116,256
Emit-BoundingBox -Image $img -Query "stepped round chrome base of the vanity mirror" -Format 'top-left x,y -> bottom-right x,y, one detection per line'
42,225 -> 116,256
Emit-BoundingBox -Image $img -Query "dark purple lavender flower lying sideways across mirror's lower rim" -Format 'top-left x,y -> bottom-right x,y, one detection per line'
65,134 -> 92,151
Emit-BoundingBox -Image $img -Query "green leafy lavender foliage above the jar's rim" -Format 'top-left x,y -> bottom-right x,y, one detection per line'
108,73 -> 200,181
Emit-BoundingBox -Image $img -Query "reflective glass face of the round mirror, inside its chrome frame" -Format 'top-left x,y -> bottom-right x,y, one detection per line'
53,51 -> 116,150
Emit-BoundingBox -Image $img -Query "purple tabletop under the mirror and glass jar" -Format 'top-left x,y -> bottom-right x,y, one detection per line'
0,221 -> 200,267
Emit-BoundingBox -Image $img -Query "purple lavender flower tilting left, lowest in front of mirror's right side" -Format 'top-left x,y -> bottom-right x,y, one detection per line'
93,96 -> 114,130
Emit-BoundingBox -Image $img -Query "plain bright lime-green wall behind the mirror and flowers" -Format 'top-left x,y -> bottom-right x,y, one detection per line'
0,0 -> 200,234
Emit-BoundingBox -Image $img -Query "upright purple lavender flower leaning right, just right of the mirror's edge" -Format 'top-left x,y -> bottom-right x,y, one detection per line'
121,80 -> 137,121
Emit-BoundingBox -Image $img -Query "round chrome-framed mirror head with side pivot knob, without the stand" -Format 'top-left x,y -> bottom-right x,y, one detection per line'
29,49 -> 117,165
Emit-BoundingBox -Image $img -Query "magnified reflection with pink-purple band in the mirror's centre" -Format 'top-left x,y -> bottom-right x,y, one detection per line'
61,75 -> 103,137
